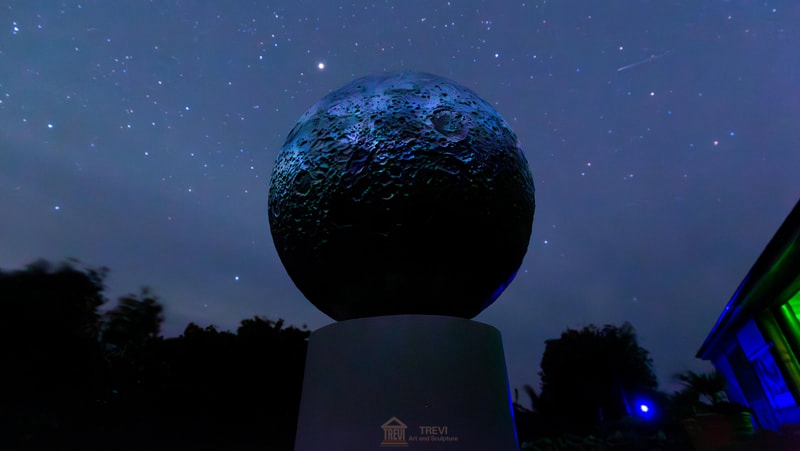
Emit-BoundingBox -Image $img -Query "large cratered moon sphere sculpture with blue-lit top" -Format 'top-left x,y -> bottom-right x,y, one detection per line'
269,72 -> 534,320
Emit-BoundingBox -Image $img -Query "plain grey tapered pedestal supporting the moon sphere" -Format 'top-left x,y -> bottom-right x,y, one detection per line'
295,315 -> 518,451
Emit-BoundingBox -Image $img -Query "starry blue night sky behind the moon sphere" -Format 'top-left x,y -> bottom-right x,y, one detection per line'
0,0 -> 800,389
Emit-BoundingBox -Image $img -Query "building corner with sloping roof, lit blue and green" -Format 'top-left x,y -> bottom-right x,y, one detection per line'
697,201 -> 800,430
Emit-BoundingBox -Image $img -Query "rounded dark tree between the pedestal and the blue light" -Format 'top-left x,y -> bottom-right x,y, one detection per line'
539,322 -> 658,433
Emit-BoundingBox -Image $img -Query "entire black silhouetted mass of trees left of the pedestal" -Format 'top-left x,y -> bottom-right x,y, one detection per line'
0,261 -> 310,451
